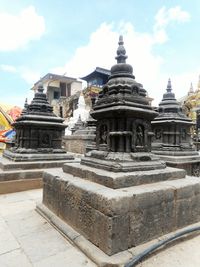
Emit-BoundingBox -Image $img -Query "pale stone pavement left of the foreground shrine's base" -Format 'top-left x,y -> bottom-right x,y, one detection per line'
0,189 -> 96,267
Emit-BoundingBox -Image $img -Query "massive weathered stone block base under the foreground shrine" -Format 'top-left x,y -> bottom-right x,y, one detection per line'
40,169 -> 200,256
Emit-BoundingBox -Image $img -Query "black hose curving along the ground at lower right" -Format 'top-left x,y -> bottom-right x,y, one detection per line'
124,226 -> 200,267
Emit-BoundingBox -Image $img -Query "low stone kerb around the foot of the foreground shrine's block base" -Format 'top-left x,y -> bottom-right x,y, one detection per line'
36,204 -> 200,267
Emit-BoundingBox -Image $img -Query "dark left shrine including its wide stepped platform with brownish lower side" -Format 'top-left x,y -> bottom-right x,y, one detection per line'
0,86 -> 74,194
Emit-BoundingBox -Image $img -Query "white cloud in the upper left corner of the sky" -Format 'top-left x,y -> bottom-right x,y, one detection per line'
0,6 -> 45,51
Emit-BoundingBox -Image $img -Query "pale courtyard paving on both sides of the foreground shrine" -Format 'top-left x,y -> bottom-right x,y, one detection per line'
0,189 -> 200,267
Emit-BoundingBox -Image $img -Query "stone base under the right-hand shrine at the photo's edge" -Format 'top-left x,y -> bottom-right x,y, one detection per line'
152,155 -> 200,177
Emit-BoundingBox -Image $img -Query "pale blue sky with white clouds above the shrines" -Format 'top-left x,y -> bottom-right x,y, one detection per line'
0,0 -> 200,107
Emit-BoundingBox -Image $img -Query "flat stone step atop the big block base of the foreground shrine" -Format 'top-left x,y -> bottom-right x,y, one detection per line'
63,163 -> 186,188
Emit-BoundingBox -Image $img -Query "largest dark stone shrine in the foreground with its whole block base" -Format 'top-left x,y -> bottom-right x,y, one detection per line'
37,36 -> 200,266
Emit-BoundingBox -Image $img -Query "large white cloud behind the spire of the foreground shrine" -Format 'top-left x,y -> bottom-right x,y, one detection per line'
51,4 -> 194,105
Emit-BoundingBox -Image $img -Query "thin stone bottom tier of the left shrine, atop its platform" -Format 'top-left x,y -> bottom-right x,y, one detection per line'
3,150 -> 74,161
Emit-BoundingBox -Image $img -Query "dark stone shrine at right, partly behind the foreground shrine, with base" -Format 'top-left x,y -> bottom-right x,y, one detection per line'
152,79 -> 200,176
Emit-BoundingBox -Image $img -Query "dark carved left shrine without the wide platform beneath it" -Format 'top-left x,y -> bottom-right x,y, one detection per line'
3,85 -> 72,161
